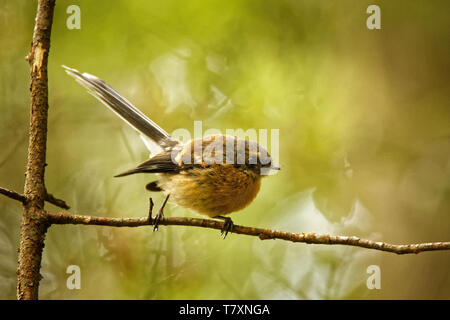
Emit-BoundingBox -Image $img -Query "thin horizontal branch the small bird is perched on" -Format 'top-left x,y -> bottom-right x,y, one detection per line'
48,211 -> 450,254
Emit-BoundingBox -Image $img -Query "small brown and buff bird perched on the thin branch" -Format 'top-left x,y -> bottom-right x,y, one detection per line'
62,66 -> 280,238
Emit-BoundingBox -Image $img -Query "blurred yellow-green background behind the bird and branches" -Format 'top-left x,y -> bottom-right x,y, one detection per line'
0,0 -> 450,299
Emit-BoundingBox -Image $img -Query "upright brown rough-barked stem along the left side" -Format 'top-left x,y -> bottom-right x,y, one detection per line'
17,0 -> 55,300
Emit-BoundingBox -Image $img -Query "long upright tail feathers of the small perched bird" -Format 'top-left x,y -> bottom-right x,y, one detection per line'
62,66 -> 177,148
